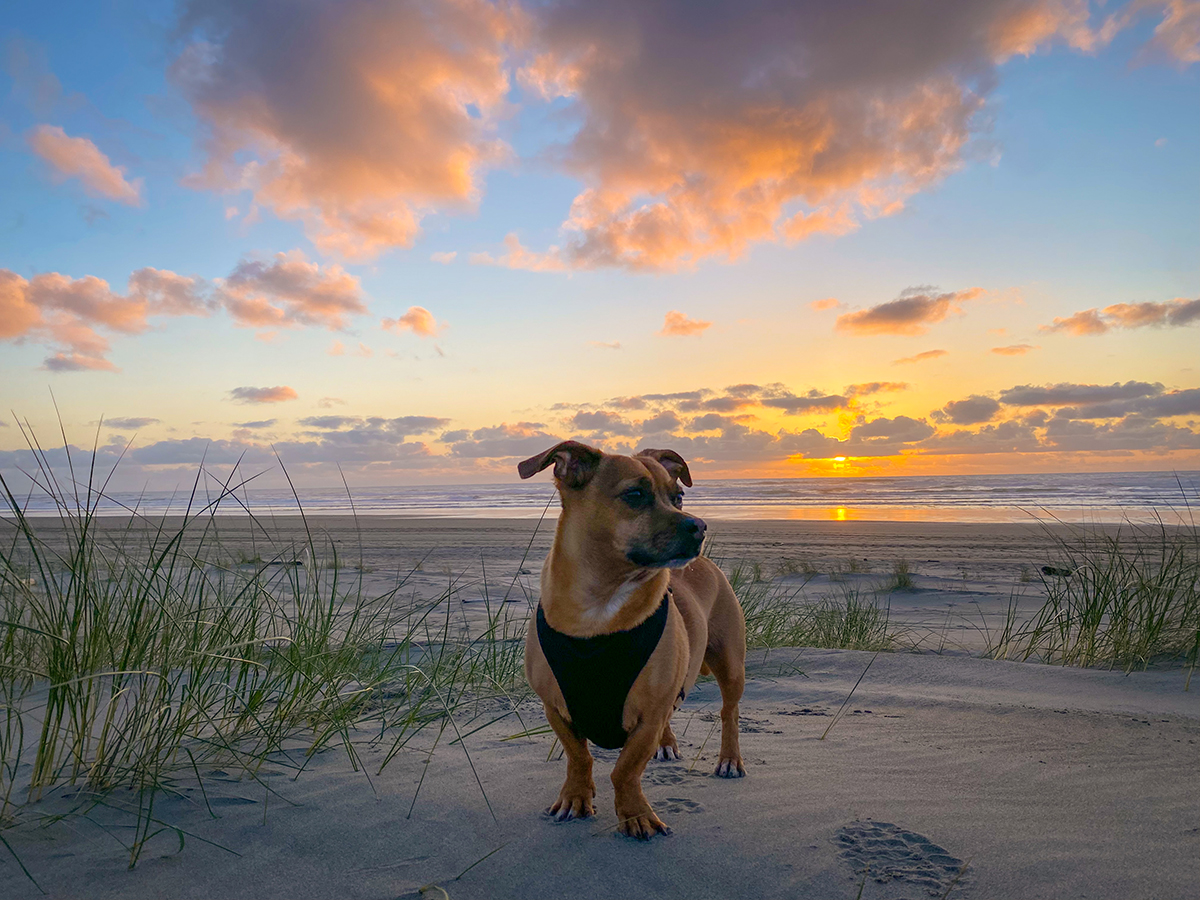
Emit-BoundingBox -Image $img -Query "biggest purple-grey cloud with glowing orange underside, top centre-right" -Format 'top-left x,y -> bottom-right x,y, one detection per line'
517,0 -> 1118,271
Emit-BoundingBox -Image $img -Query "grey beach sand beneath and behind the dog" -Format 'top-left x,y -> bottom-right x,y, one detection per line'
0,518 -> 1200,899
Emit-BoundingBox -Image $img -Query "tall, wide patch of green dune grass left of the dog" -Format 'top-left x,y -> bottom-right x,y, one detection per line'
0,441 -> 524,877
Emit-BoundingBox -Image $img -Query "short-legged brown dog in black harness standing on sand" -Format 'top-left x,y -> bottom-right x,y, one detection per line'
517,440 -> 745,840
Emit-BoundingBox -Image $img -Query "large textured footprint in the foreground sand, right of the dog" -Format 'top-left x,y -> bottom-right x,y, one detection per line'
833,821 -> 966,896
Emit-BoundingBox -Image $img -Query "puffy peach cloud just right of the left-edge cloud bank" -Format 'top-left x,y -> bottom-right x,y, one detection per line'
217,250 -> 367,330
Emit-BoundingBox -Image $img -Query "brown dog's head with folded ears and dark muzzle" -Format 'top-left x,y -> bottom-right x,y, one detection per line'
517,440 -> 706,569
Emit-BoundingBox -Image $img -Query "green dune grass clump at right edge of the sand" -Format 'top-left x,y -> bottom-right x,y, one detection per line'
989,520 -> 1200,671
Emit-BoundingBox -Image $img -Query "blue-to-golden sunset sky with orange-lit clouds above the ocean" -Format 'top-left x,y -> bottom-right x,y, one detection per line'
0,0 -> 1200,490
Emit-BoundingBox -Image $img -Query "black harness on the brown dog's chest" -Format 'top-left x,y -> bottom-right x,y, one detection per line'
538,594 -> 671,750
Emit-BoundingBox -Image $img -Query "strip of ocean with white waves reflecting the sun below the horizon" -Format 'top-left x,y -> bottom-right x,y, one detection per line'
7,472 -> 1200,524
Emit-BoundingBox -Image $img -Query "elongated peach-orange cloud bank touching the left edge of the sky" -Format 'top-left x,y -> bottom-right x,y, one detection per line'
0,269 -> 211,372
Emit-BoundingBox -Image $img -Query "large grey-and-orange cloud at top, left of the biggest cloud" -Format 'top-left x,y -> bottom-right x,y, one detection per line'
172,0 -> 521,259
